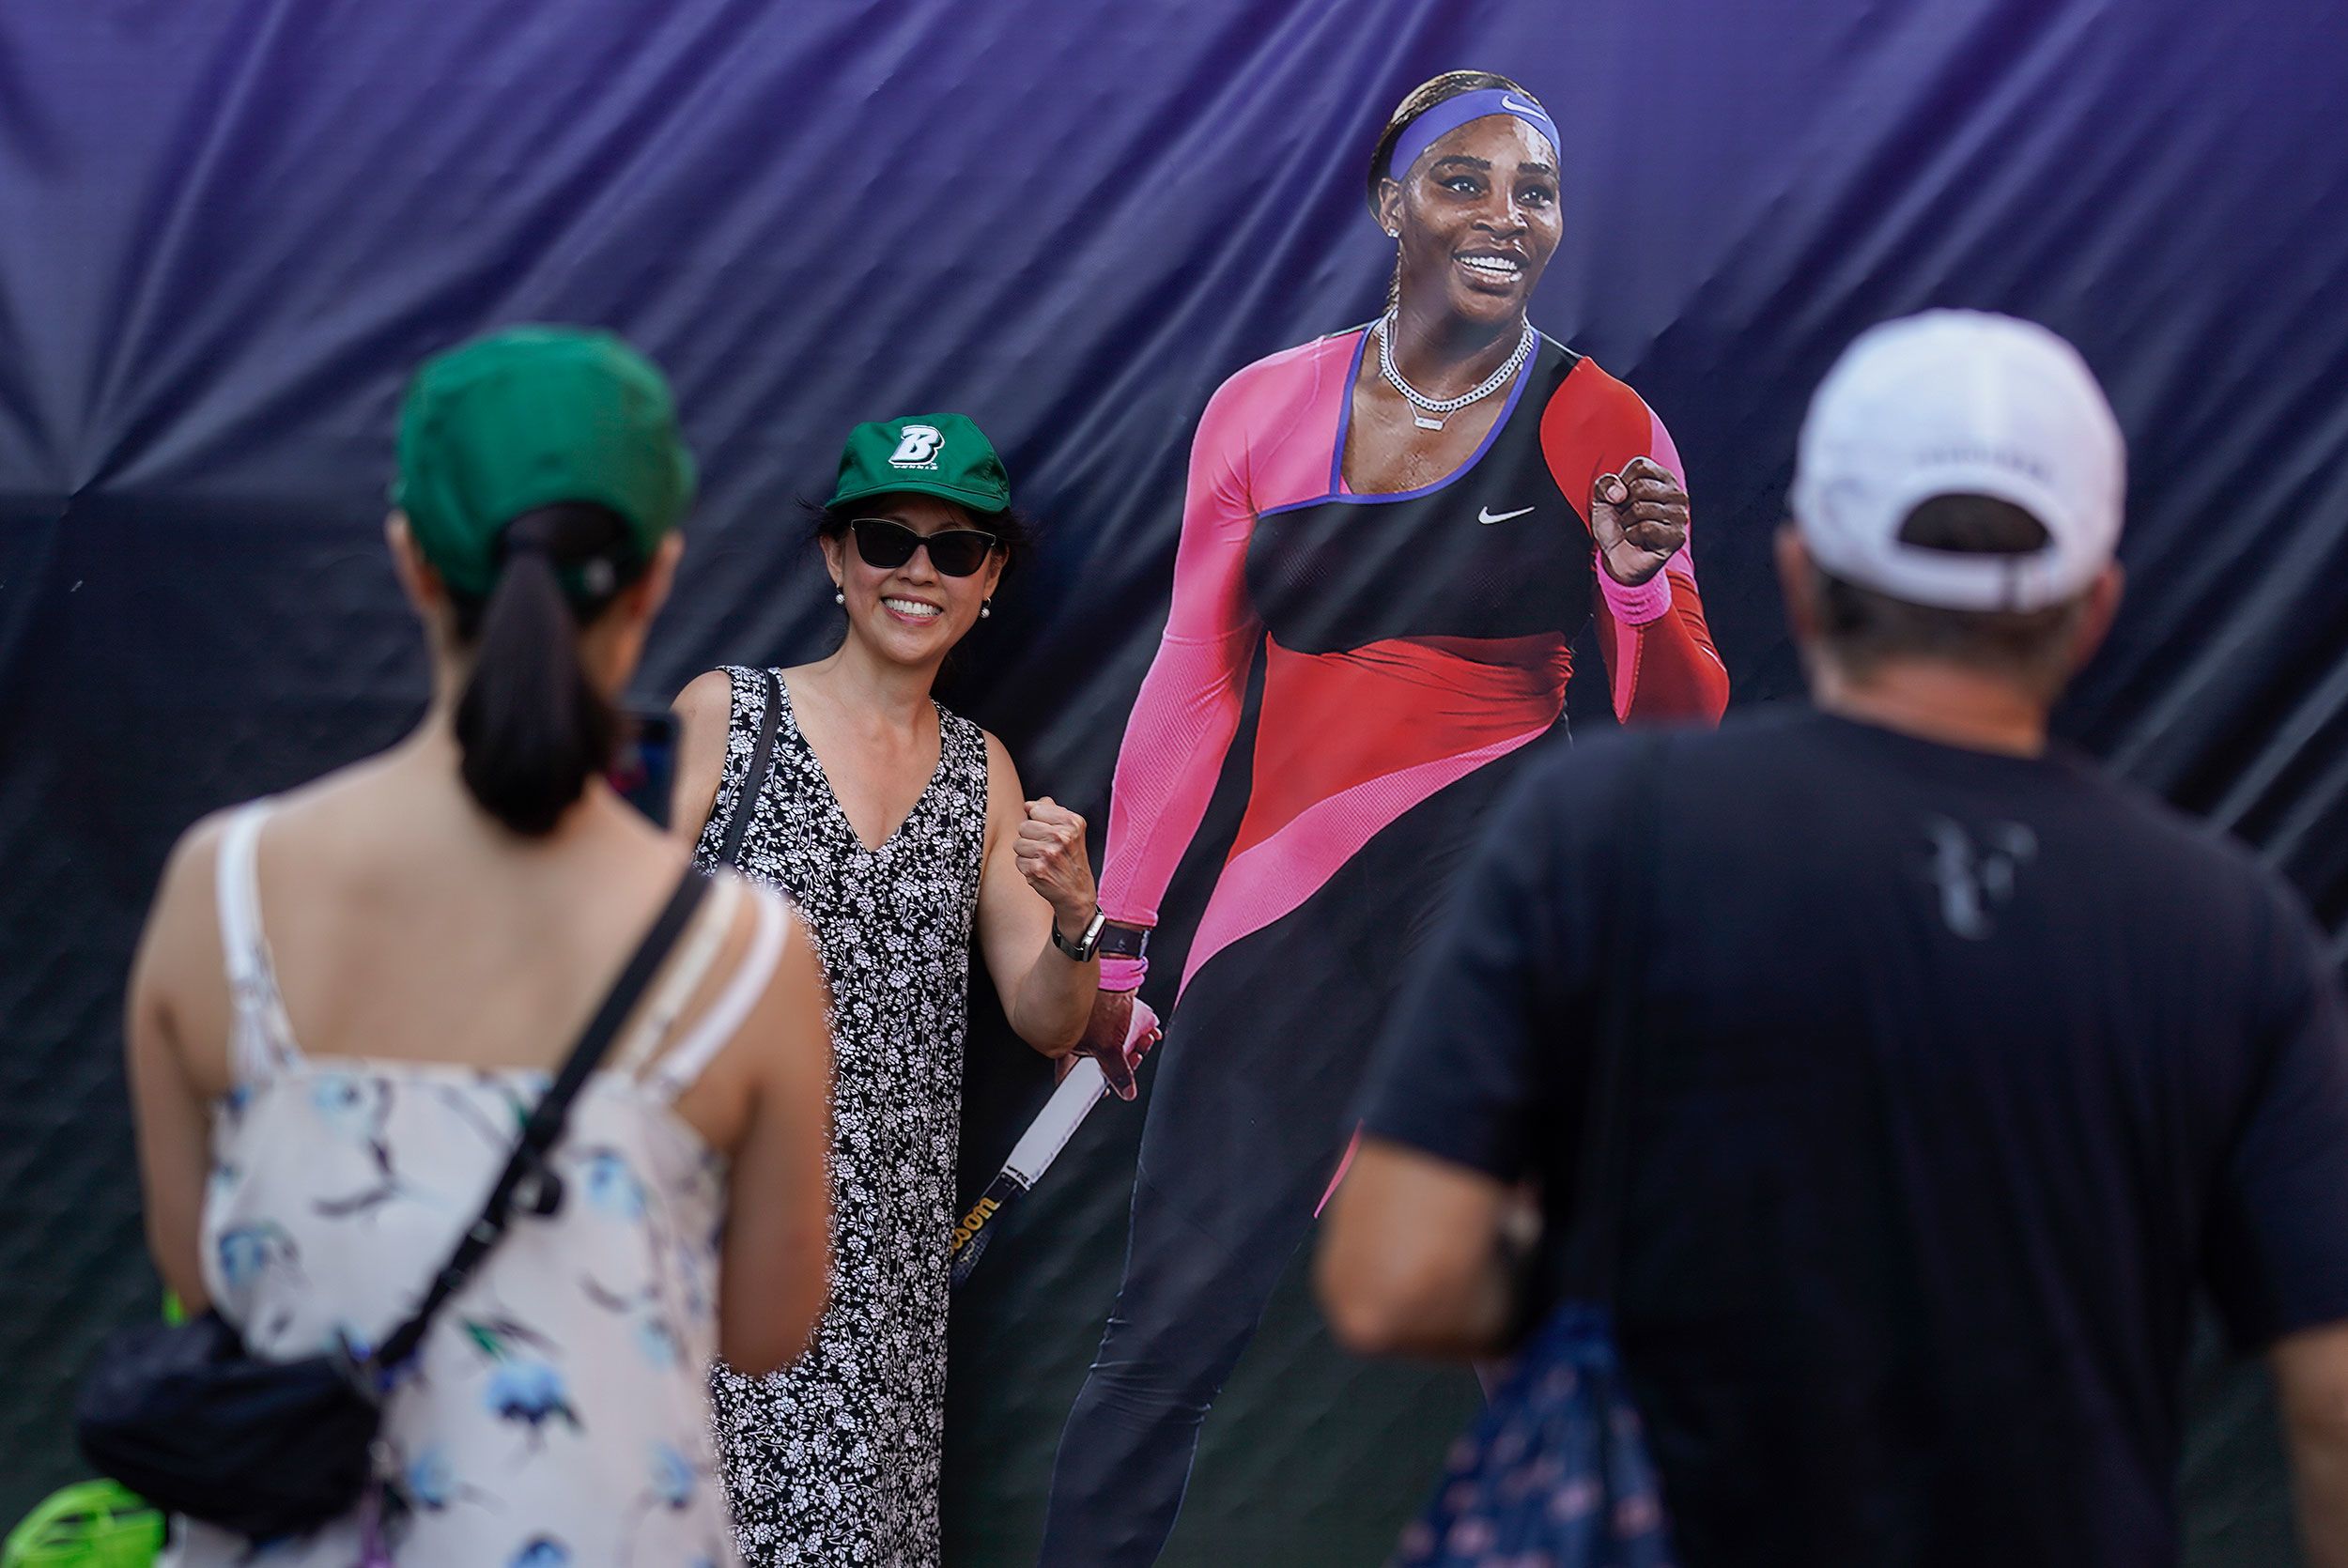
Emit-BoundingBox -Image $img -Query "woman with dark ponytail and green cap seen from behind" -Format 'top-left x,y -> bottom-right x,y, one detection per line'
130,329 -> 831,1568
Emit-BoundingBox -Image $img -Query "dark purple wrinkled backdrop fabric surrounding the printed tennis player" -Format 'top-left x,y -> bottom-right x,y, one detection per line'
0,0 -> 2348,1563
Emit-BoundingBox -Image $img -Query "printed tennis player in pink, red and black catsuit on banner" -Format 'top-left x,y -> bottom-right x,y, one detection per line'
1043,70 -> 1728,1568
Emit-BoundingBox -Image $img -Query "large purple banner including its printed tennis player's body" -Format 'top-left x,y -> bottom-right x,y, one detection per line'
0,0 -> 2348,1566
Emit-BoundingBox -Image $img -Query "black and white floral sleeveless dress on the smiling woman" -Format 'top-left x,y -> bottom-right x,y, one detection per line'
698,669 -> 986,1568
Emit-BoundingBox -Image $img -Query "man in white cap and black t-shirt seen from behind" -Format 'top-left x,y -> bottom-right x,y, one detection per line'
1320,313 -> 2348,1568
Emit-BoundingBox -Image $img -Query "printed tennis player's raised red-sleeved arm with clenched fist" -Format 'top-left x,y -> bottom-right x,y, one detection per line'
1540,382 -> 1728,726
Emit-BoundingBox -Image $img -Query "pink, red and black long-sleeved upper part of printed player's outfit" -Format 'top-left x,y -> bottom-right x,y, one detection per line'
1102,329 -> 1728,1000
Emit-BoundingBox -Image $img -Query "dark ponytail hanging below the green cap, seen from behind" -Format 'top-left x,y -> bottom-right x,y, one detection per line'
456,502 -> 646,838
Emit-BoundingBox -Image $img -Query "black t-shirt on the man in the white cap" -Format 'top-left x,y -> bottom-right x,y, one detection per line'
1367,712 -> 2348,1568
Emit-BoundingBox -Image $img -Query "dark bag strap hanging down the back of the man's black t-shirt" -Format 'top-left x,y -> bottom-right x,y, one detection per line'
1568,735 -> 1667,1308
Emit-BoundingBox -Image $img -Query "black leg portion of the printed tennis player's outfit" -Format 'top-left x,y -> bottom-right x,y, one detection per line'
1043,751 -> 1524,1568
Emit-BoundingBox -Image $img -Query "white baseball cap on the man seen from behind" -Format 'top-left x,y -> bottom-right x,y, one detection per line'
1792,310 -> 2127,610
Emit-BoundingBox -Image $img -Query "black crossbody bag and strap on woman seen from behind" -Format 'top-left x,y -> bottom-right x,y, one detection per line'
73,871 -> 709,1543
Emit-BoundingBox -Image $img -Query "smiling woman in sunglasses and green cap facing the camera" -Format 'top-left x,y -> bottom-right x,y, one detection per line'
674,413 -> 1102,1566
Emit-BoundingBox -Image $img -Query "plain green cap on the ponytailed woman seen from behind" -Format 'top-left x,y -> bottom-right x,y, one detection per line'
393,327 -> 693,594
